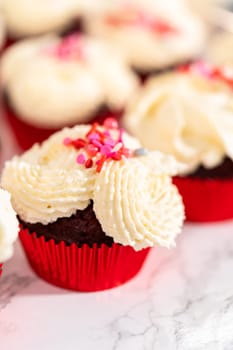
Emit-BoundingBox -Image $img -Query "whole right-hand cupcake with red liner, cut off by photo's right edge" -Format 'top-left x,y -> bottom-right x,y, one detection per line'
124,62 -> 233,221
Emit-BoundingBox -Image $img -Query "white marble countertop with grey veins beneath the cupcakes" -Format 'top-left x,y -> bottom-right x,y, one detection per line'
0,117 -> 233,350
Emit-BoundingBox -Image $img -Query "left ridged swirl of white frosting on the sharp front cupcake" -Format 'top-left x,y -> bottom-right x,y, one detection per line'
2,125 -> 139,224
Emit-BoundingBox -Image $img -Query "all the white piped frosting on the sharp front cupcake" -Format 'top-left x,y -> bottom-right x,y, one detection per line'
1,125 -> 184,250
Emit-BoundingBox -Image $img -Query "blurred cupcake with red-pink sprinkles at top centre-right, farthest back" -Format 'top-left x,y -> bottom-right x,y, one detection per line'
84,0 -> 206,77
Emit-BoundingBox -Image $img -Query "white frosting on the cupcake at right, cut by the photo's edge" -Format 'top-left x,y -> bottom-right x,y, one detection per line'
124,73 -> 233,173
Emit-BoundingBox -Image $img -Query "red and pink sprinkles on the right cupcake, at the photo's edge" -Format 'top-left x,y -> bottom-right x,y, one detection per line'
178,61 -> 233,88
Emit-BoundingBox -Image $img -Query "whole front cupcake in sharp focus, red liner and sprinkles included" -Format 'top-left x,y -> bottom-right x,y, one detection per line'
1,118 -> 184,291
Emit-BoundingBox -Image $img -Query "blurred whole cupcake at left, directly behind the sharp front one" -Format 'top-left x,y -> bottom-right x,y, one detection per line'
1,34 -> 138,149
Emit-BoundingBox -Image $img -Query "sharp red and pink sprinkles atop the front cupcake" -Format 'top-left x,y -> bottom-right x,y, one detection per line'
63,118 -> 132,172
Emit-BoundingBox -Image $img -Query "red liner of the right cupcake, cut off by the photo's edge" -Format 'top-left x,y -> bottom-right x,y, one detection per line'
173,176 -> 233,222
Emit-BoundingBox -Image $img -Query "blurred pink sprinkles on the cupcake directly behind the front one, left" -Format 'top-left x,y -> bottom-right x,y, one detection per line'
47,33 -> 85,60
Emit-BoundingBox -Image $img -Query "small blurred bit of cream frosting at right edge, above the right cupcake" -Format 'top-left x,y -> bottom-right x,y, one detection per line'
206,32 -> 233,66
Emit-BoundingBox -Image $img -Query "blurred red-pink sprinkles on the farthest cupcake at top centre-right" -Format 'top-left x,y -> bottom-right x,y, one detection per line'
105,9 -> 178,35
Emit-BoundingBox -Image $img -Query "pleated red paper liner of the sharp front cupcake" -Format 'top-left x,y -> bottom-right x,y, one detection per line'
19,229 -> 149,292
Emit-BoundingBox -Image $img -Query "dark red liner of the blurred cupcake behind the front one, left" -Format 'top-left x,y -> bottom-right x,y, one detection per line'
2,101 -> 122,151
